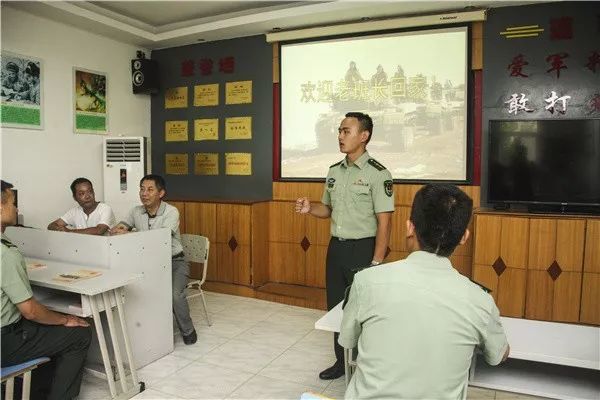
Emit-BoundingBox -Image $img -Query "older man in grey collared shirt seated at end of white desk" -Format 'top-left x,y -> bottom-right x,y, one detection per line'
110,175 -> 198,344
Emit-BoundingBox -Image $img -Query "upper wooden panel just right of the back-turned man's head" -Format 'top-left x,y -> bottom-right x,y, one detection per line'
473,215 -> 502,265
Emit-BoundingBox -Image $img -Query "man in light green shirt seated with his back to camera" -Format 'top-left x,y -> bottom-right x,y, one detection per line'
339,184 -> 509,399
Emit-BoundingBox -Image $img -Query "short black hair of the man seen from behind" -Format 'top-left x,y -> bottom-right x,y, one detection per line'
410,183 -> 473,257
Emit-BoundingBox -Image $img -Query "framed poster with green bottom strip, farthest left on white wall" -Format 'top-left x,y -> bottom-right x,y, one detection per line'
0,51 -> 44,129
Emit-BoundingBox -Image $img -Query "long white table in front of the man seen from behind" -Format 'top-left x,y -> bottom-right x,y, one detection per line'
315,302 -> 600,399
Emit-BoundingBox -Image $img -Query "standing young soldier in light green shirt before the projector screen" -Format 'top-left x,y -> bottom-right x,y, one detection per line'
296,112 -> 394,379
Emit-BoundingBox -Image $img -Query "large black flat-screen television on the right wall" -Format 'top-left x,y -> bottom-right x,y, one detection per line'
487,119 -> 600,213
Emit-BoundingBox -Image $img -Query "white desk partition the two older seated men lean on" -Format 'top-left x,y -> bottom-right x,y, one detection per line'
5,227 -> 173,368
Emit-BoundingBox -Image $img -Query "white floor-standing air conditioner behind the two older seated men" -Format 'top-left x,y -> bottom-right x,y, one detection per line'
102,137 -> 146,222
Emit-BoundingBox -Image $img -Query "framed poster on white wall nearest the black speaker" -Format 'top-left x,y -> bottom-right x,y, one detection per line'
73,67 -> 108,135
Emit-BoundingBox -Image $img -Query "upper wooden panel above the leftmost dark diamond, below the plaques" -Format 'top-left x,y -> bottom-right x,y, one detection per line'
217,204 -> 251,244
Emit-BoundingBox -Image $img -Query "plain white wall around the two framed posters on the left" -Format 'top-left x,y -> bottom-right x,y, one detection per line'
0,4 -> 150,228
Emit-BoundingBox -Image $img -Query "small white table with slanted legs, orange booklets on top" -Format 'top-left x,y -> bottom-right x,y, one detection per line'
26,258 -> 145,399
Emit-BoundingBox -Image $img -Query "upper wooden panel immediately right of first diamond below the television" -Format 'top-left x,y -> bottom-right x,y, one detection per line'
500,217 -> 529,270
